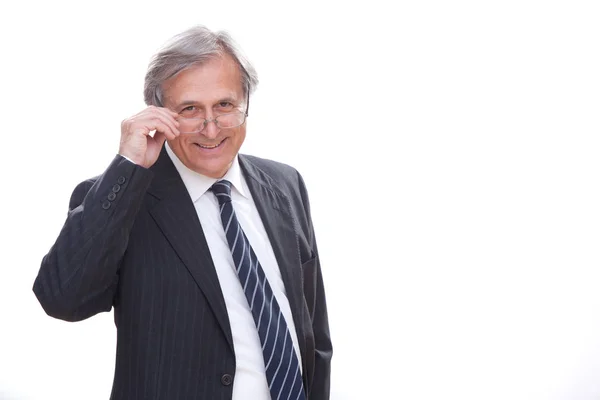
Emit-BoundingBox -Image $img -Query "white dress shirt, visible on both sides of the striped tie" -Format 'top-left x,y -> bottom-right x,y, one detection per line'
165,144 -> 302,400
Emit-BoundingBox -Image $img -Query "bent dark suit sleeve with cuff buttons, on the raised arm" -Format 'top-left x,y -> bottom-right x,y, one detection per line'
33,155 -> 152,321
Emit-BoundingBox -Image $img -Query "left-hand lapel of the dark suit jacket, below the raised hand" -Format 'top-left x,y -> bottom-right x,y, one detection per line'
148,147 -> 234,351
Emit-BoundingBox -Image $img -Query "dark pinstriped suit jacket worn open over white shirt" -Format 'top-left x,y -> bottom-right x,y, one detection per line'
33,149 -> 332,400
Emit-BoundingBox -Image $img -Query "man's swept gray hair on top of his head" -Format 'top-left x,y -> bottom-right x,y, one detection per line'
144,26 -> 258,107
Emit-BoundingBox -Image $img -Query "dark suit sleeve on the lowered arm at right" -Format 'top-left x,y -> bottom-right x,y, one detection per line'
298,170 -> 333,400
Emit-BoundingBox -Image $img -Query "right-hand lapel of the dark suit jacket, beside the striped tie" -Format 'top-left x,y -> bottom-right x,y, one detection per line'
239,154 -> 306,366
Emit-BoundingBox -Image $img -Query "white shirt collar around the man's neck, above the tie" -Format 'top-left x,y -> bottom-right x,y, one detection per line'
165,143 -> 250,202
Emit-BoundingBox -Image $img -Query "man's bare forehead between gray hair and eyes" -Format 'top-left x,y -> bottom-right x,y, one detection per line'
162,55 -> 243,103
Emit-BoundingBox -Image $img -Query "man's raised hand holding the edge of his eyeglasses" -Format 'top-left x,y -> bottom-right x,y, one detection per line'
119,106 -> 179,168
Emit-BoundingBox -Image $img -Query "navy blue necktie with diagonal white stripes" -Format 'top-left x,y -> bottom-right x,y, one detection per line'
212,180 -> 305,400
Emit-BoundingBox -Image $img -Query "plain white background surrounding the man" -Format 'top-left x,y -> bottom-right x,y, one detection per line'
0,0 -> 600,400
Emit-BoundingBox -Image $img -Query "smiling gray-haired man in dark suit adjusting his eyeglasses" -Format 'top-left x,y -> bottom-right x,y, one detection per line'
33,27 -> 332,400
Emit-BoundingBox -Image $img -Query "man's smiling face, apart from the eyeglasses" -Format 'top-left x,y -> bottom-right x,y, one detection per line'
163,56 -> 246,178
